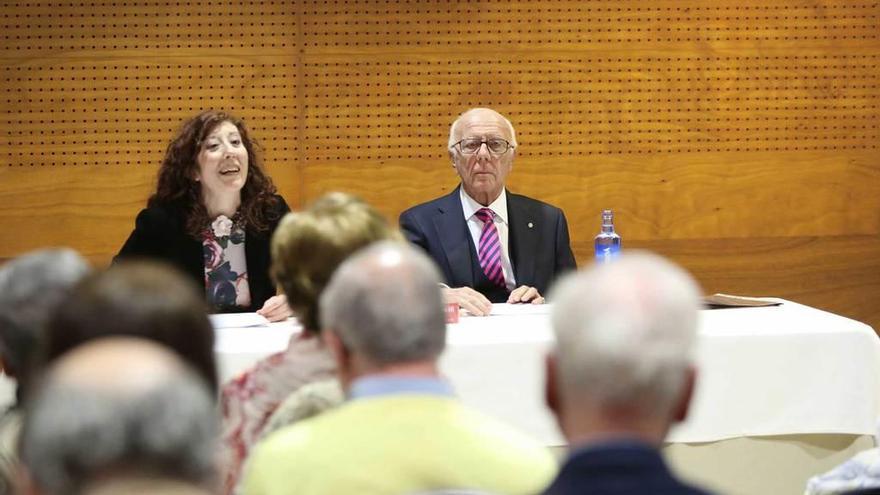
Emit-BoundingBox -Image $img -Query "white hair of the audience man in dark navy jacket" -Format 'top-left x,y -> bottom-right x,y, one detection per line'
552,252 -> 700,417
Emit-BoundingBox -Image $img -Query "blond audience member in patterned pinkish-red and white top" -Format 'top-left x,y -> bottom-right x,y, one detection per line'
221,192 -> 402,493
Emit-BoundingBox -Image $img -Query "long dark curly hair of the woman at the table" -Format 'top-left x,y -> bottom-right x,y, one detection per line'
148,110 -> 278,239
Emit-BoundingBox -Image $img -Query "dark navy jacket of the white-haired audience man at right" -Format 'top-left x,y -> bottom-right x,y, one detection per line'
544,441 -> 709,495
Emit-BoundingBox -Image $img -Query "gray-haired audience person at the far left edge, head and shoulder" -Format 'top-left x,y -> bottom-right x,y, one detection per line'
0,249 -> 90,494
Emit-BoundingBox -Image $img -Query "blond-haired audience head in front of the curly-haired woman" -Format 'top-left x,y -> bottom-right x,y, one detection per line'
272,192 -> 402,332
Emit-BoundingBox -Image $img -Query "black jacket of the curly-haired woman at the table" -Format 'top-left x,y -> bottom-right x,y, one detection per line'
113,196 -> 290,311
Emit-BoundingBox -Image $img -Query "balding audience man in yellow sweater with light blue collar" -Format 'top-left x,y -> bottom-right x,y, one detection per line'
243,242 -> 556,495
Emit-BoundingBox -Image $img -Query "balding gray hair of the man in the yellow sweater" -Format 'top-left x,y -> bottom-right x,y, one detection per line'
320,241 -> 446,365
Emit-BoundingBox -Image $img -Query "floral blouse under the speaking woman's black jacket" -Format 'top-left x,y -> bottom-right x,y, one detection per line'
202,215 -> 251,311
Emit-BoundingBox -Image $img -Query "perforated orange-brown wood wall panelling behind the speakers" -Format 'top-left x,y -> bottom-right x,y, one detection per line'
0,0 -> 880,327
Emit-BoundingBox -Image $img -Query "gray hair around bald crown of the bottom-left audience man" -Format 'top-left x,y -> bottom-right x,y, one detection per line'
20,367 -> 219,495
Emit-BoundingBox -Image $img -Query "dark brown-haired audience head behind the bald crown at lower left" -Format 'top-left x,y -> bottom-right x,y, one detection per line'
45,261 -> 217,390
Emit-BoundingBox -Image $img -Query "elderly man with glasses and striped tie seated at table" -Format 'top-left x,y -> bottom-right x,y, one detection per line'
400,108 -> 576,315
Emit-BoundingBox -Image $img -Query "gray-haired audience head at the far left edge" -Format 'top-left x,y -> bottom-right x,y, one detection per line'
0,249 -> 91,399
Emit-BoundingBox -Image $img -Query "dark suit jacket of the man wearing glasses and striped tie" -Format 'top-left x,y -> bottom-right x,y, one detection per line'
400,186 -> 577,302
